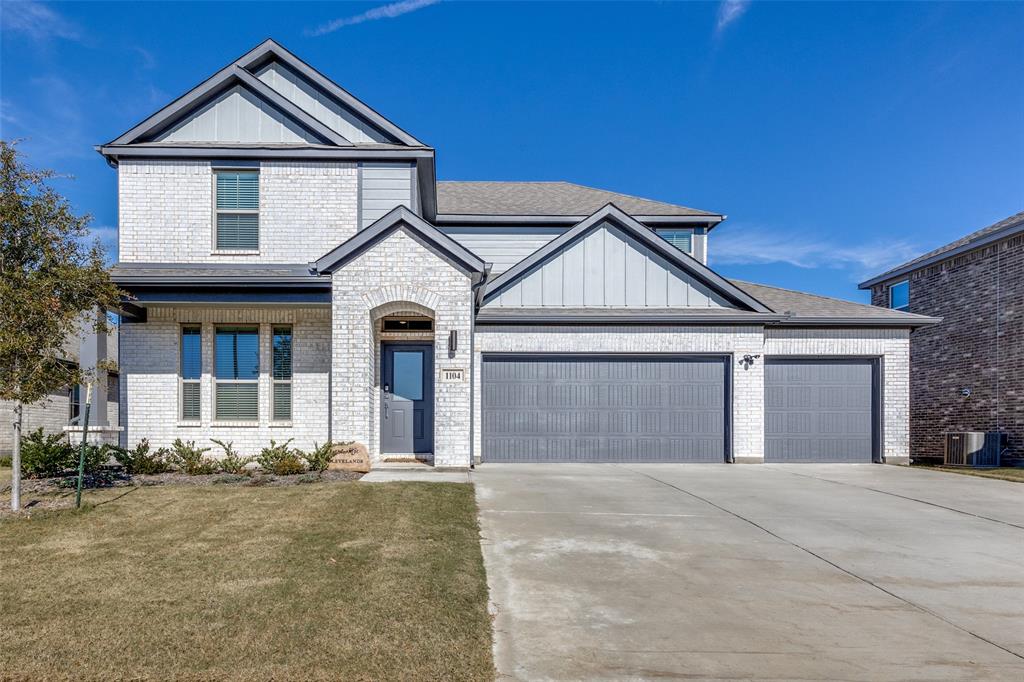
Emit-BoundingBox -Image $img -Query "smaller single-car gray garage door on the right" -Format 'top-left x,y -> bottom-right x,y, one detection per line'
765,358 -> 878,462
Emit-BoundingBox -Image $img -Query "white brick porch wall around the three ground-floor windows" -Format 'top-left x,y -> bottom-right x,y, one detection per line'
121,306 -> 331,456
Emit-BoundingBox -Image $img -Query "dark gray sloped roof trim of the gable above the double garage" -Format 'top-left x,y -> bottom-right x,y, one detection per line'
484,204 -> 771,312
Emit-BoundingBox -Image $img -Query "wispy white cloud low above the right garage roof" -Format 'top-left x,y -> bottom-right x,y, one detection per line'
708,224 -> 921,278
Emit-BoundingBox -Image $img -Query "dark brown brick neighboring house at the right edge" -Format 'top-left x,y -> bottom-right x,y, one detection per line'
860,212 -> 1024,464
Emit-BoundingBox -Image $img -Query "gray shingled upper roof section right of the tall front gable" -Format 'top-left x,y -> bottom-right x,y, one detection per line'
437,181 -> 724,222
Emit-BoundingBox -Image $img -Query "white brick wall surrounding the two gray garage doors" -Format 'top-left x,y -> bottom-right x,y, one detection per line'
473,327 -> 909,461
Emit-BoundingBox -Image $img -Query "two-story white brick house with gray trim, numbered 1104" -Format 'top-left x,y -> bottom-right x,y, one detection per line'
105,41 -> 935,467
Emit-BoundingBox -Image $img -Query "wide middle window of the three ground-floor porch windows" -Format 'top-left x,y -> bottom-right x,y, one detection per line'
214,326 -> 259,422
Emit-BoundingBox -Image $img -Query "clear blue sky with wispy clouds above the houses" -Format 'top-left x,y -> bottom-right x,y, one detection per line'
0,0 -> 1024,301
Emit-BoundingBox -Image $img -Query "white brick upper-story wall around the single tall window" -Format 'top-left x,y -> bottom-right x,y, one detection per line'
118,160 -> 358,263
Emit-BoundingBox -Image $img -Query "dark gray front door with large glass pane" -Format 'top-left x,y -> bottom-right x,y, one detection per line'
381,343 -> 434,455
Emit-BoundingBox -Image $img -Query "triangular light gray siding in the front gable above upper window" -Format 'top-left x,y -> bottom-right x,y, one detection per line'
156,85 -> 321,144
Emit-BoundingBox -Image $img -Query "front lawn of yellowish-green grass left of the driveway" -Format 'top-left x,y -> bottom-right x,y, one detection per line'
0,482 -> 495,680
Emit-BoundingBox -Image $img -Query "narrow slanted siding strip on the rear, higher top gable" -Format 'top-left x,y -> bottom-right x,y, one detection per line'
256,61 -> 394,144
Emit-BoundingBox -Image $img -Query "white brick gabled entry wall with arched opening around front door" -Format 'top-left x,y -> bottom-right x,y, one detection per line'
331,229 -> 473,467
